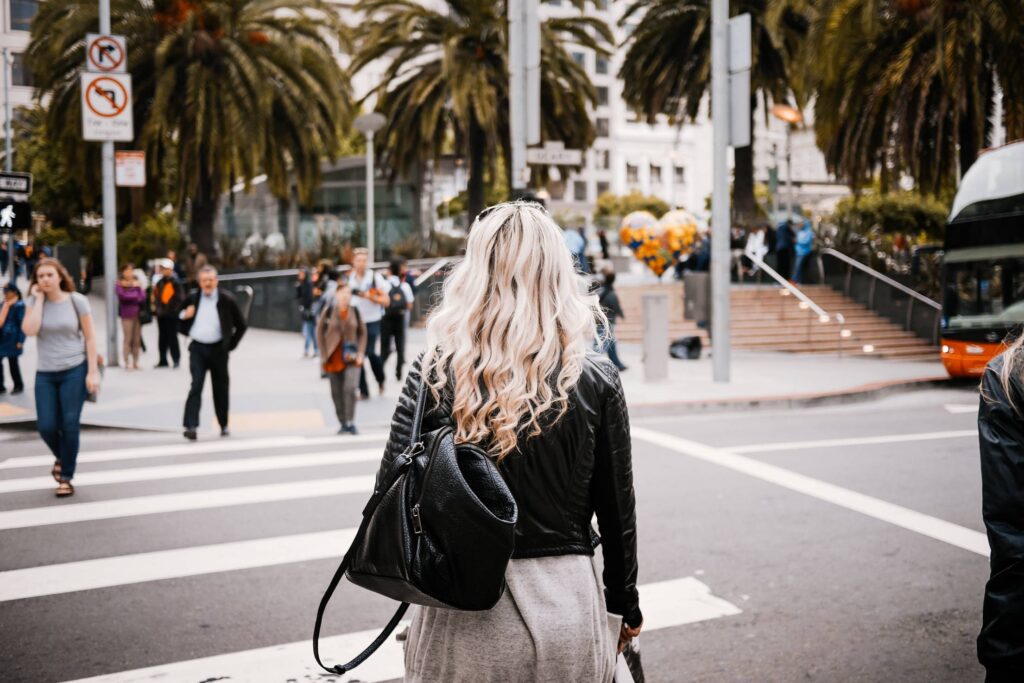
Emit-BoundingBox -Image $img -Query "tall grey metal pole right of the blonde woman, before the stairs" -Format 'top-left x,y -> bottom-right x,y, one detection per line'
711,0 -> 731,382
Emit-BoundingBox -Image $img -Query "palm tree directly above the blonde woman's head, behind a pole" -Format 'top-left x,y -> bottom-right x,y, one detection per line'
351,0 -> 613,218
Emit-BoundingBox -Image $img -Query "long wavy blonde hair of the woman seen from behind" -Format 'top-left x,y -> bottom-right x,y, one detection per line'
422,202 -> 607,461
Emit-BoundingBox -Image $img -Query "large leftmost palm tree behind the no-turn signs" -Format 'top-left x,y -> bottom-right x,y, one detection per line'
28,0 -> 348,253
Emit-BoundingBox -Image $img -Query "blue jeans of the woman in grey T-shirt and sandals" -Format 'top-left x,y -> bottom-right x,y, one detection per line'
36,362 -> 88,481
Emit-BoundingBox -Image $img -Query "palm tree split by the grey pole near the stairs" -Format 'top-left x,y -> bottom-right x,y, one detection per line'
618,0 -> 808,224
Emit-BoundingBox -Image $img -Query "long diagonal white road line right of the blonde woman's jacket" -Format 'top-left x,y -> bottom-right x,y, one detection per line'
631,427 -> 988,557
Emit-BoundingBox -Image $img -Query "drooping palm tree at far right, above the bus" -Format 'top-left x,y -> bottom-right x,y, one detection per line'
814,0 -> 1024,193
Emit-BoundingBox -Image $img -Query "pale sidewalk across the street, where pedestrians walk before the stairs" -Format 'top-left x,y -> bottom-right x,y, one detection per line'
0,297 -> 945,438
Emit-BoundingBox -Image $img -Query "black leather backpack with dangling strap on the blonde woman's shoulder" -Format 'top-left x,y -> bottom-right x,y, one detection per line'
313,381 -> 518,675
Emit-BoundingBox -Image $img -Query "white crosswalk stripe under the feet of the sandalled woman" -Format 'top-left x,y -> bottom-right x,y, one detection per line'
0,449 -> 381,494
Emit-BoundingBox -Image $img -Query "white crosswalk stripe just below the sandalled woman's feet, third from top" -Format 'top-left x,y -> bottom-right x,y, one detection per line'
0,475 -> 375,530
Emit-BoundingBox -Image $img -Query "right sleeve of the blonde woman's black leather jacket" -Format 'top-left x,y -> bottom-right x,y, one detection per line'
591,359 -> 643,627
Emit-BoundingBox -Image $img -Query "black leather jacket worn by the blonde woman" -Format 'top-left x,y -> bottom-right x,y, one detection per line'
382,353 -> 643,627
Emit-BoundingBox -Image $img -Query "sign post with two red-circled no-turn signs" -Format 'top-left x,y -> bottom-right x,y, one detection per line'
82,14 -> 135,367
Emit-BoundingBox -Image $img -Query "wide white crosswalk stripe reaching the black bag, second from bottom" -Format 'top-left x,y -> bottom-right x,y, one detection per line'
0,528 -> 355,601
